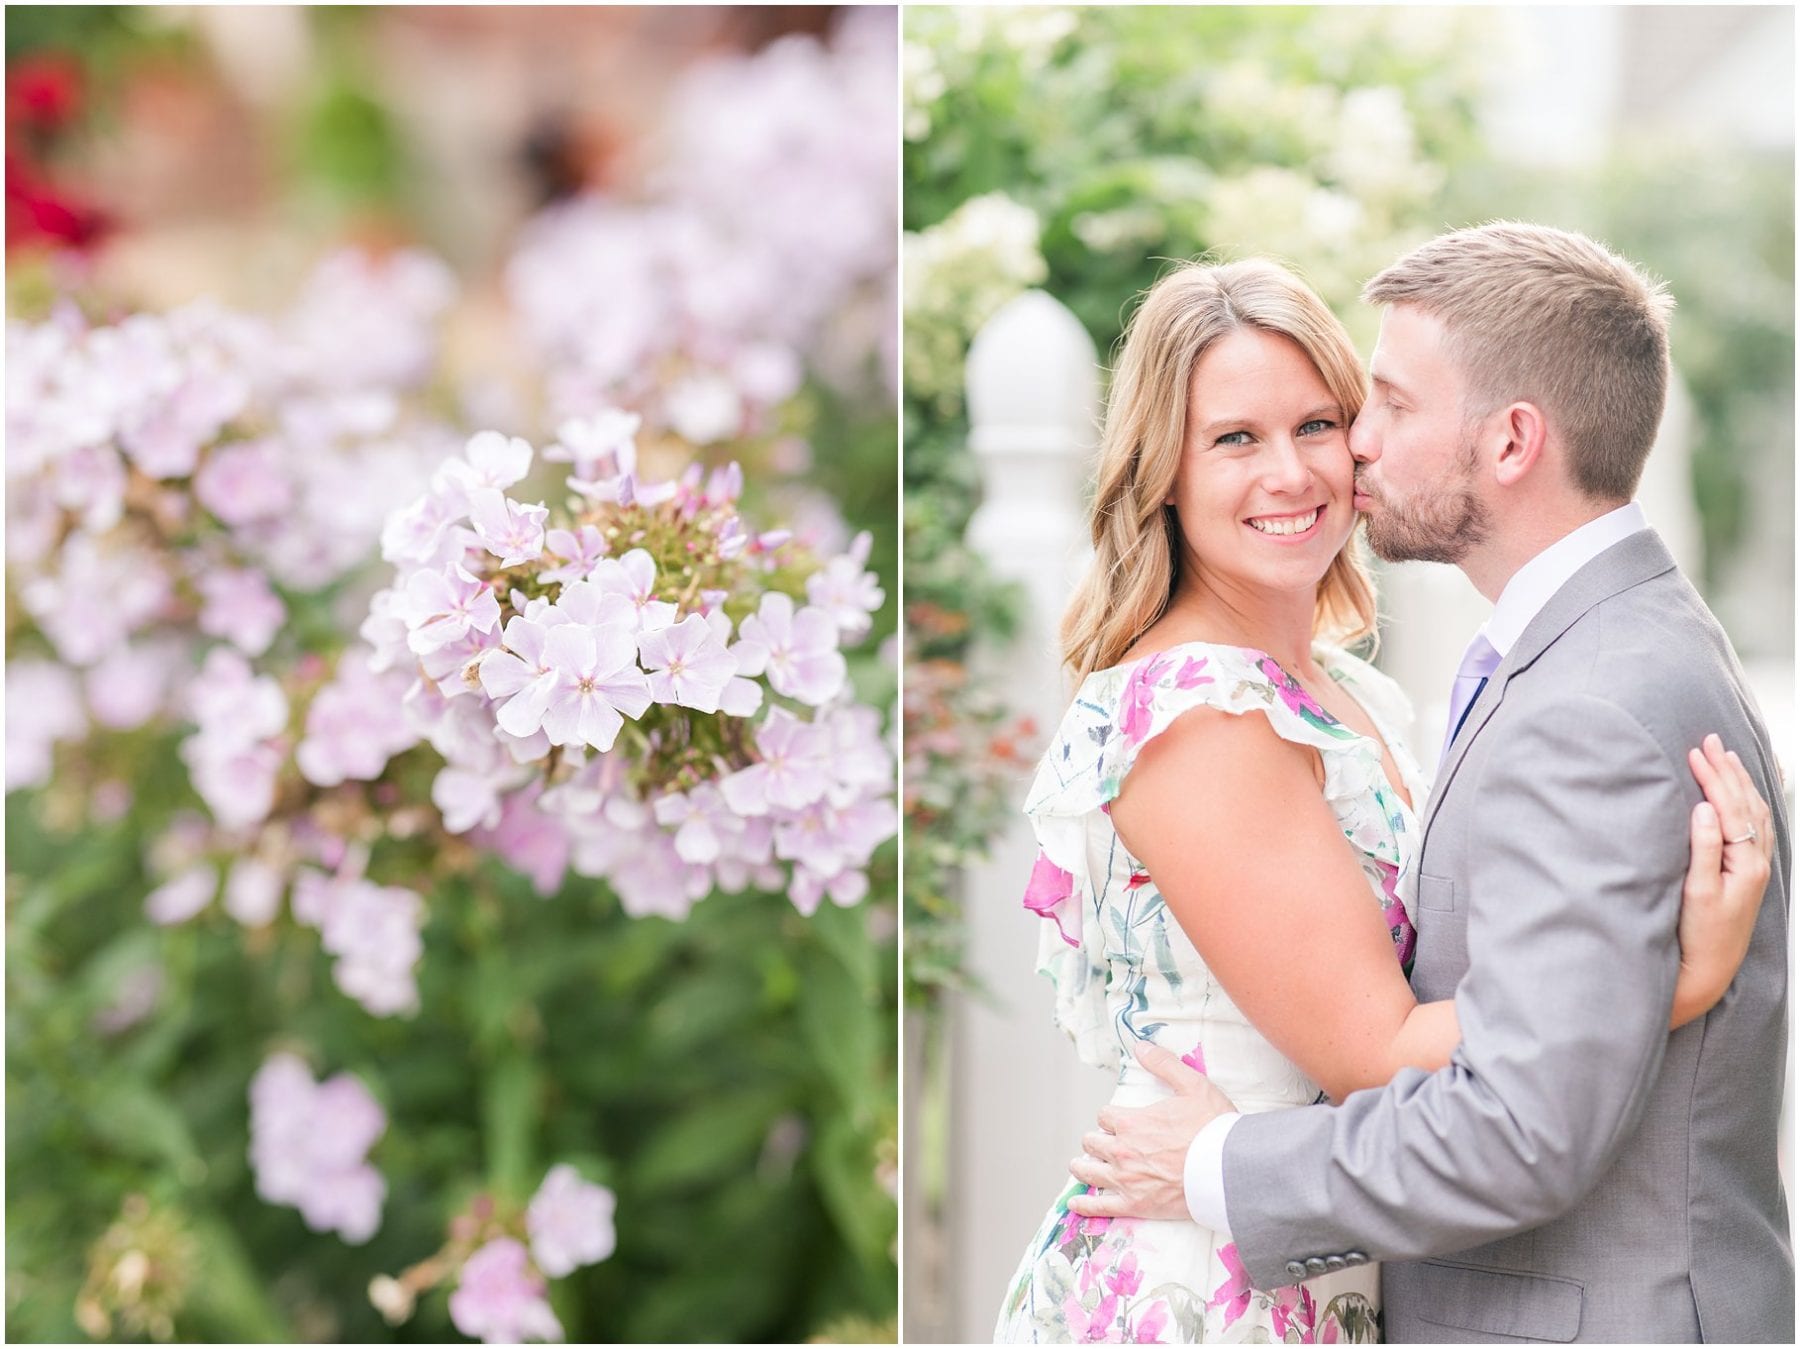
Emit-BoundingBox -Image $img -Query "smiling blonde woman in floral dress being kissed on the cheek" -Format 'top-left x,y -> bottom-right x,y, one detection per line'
995,261 -> 1773,1342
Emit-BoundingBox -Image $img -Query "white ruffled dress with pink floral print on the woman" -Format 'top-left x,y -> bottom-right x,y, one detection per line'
994,643 -> 1426,1344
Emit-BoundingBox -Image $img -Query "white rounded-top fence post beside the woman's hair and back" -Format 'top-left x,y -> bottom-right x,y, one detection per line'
947,290 -> 1112,1340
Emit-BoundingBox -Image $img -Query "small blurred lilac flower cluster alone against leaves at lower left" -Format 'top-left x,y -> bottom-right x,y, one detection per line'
250,1054 -> 387,1245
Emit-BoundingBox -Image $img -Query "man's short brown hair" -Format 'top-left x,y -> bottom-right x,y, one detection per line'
1363,222 -> 1674,501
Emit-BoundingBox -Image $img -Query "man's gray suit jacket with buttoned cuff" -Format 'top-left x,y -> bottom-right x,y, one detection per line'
1224,533 -> 1795,1344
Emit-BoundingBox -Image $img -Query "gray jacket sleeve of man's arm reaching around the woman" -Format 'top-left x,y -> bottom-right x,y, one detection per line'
1224,695 -> 1688,1288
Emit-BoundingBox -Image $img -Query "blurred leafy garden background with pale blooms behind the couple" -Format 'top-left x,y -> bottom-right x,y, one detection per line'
902,5 -> 1795,1338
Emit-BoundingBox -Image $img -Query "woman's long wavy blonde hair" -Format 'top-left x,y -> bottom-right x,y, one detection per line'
1062,258 -> 1375,683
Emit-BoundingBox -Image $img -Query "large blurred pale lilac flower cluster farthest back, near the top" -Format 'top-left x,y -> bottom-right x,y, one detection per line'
506,11 -> 898,445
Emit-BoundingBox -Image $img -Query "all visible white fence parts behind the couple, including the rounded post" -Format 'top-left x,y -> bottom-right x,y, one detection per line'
907,292 -> 1793,1340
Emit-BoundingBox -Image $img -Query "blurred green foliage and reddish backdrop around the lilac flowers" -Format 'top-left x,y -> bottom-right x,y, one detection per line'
5,5 -> 900,1342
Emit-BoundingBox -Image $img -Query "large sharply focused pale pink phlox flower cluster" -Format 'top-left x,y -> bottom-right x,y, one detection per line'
361,409 -> 895,917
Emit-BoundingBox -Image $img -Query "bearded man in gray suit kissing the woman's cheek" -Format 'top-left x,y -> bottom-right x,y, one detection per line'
1071,223 -> 1795,1344
